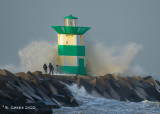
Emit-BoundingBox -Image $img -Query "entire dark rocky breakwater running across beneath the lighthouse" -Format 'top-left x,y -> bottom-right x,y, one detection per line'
0,70 -> 160,114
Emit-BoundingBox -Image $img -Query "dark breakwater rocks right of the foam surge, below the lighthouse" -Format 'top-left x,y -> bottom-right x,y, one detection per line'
55,74 -> 160,102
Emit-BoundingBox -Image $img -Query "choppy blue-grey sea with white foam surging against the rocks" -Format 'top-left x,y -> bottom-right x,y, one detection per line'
53,84 -> 160,114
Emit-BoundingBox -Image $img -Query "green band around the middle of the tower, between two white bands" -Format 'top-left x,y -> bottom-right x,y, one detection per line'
58,45 -> 85,56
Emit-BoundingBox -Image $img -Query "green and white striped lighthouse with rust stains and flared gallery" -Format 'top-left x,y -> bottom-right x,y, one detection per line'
51,15 -> 90,76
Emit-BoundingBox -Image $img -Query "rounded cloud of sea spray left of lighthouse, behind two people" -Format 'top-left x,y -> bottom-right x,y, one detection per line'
18,41 -> 58,71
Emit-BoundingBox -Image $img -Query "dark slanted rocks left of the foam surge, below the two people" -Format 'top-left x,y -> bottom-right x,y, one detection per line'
0,70 -> 79,114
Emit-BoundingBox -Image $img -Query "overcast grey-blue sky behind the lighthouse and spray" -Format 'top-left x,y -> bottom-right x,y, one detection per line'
0,0 -> 160,75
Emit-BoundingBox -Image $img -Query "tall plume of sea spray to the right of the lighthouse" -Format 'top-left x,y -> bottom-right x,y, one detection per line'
86,43 -> 143,76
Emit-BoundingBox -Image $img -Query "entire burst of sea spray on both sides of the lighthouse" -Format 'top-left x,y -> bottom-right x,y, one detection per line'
2,41 -> 143,76
